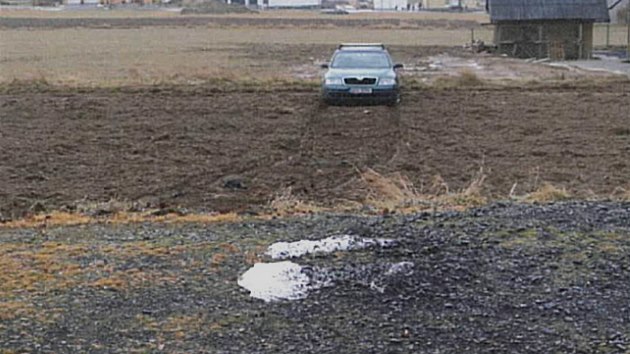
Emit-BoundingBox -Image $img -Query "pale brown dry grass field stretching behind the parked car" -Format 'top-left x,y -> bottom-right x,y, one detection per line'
0,10 -> 625,87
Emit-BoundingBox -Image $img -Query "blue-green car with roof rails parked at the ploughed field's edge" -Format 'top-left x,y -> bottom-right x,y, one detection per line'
322,43 -> 403,105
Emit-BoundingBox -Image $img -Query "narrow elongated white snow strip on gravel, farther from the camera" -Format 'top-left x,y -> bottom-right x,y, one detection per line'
265,235 -> 395,259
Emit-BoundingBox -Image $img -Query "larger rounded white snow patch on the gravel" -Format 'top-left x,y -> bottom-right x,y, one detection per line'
238,261 -> 324,302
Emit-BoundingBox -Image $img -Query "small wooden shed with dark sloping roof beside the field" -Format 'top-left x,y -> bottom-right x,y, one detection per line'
487,0 -> 610,60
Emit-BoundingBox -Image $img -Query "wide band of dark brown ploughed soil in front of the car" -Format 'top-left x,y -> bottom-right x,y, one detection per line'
0,84 -> 630,219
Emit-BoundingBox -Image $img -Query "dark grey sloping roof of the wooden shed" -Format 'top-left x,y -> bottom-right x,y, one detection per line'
487,0 -> 610,23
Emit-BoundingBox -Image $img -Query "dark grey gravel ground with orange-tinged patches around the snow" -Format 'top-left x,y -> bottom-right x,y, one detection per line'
0,202 -> 630,353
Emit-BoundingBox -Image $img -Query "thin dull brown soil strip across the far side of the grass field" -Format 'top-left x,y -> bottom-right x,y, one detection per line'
0,16 -> 480,29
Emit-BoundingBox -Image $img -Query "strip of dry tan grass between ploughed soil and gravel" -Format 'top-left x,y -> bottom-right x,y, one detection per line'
0,180 -> 630,230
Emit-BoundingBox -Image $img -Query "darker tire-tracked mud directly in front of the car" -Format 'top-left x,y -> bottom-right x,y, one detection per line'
299,104 -> 407,196
